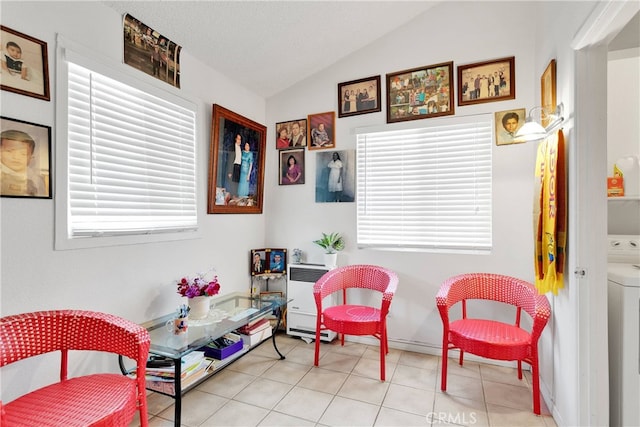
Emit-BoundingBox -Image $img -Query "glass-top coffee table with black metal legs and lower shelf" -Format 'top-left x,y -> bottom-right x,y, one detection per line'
120,292 -> 288,426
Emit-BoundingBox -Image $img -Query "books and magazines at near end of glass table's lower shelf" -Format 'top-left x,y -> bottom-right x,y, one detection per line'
145,351 -> 211,396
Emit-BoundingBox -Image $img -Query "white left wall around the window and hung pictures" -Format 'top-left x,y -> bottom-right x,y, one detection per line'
0,2 -> 269,401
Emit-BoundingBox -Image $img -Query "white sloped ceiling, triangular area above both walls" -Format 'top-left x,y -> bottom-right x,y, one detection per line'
103,0 -> 438,98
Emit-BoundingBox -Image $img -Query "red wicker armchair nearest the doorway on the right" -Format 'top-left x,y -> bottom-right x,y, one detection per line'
436,273 -> 551,415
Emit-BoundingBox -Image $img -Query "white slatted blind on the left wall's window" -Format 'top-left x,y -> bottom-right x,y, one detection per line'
67,62 -> 197,237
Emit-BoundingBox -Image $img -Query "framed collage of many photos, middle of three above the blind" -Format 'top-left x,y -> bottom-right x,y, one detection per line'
387,62 -> 455,123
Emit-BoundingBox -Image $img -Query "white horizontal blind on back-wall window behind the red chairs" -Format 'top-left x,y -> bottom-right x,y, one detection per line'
357,115 -> 493,251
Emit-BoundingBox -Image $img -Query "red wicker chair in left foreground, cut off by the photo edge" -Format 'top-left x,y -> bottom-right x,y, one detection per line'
0,310 -> 150,427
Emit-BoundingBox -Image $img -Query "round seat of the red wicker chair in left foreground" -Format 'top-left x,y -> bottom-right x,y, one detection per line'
3,374 -> 138,427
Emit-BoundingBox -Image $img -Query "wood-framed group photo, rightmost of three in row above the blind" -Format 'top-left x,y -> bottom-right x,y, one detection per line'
458,56 -> 516,106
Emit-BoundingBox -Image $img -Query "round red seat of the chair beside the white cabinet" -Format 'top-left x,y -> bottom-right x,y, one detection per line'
323,305 -> 381,335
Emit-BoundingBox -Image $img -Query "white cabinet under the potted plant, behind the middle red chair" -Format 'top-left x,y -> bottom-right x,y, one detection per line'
287,264 -> 338,341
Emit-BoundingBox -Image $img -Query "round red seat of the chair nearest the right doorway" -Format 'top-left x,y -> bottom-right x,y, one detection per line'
449,319 -> 531,360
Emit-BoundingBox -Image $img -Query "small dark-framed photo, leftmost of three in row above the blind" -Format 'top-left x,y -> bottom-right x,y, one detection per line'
338,76 -> 382,117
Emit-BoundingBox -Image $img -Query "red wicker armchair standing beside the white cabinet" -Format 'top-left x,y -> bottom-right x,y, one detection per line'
313,265 -> 398,381
